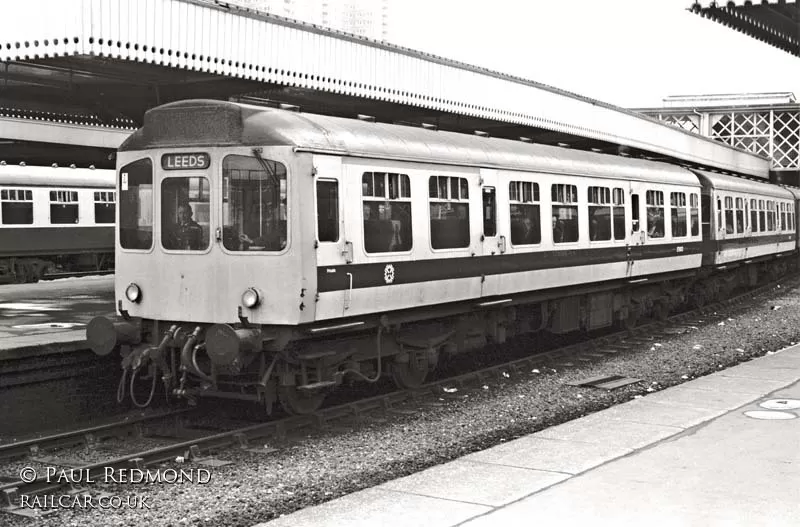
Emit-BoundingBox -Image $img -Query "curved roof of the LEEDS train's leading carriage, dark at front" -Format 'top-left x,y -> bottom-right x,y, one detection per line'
120,100 -> 699,187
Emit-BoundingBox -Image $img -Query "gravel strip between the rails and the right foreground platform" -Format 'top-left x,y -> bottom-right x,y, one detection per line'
6,286 -> 800,527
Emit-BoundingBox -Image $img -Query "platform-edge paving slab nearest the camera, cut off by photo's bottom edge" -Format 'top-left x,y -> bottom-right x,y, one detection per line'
262,488 -> 493,527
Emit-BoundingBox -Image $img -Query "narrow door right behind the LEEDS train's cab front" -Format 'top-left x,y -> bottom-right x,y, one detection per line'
314,156 -> 352,320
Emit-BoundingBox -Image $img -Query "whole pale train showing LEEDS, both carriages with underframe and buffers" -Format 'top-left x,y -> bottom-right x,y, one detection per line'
87,101 -> 800,413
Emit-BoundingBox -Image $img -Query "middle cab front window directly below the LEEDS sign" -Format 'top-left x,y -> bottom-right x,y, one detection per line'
161,177 -> 210,251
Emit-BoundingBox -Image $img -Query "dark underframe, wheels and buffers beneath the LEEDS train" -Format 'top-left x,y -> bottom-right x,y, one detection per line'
92,255 -> 796,414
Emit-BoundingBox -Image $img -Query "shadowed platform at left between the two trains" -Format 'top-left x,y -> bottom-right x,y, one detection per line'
0,276 -> 114,361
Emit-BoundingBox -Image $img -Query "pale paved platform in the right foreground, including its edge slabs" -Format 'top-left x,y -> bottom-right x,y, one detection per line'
258,346 -> 800,527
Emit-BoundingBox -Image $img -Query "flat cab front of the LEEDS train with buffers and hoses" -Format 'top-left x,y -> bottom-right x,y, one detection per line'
87,140 -> 311,412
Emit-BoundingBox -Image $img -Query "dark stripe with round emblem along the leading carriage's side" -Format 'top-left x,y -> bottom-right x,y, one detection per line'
317,242 -> 702,293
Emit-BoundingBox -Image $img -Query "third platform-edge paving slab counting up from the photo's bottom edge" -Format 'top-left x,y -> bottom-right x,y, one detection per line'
462,434 -> 632,474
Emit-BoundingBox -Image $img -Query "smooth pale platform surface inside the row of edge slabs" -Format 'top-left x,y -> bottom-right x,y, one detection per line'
462,387 -> 800,527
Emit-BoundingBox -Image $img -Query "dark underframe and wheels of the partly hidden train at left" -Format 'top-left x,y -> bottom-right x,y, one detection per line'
0,252 -> 114,284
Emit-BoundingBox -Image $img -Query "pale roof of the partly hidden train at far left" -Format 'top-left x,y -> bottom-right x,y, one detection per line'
0,165 -> 116,189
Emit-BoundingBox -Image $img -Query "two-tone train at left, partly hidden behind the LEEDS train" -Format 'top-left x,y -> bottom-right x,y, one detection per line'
0,163 -> 116,283
